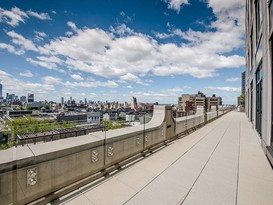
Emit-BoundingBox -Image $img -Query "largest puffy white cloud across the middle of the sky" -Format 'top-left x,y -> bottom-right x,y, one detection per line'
33,22 -> 245,80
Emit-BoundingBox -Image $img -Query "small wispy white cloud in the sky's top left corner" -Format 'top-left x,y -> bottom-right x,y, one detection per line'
0,7 -> 51,27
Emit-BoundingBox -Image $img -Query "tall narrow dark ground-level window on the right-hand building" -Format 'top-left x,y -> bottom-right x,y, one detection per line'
256,63 -> 263,136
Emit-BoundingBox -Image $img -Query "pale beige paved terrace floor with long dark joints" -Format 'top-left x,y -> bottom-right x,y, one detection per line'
51,111 -> 273,205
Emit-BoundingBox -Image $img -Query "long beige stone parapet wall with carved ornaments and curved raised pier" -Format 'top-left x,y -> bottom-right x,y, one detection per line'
0,106 -> 226,204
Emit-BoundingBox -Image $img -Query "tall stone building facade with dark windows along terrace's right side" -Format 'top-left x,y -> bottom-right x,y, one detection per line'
245,0 -> 273,161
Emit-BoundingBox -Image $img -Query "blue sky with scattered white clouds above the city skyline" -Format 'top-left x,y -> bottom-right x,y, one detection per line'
0,0 -> 245,104
